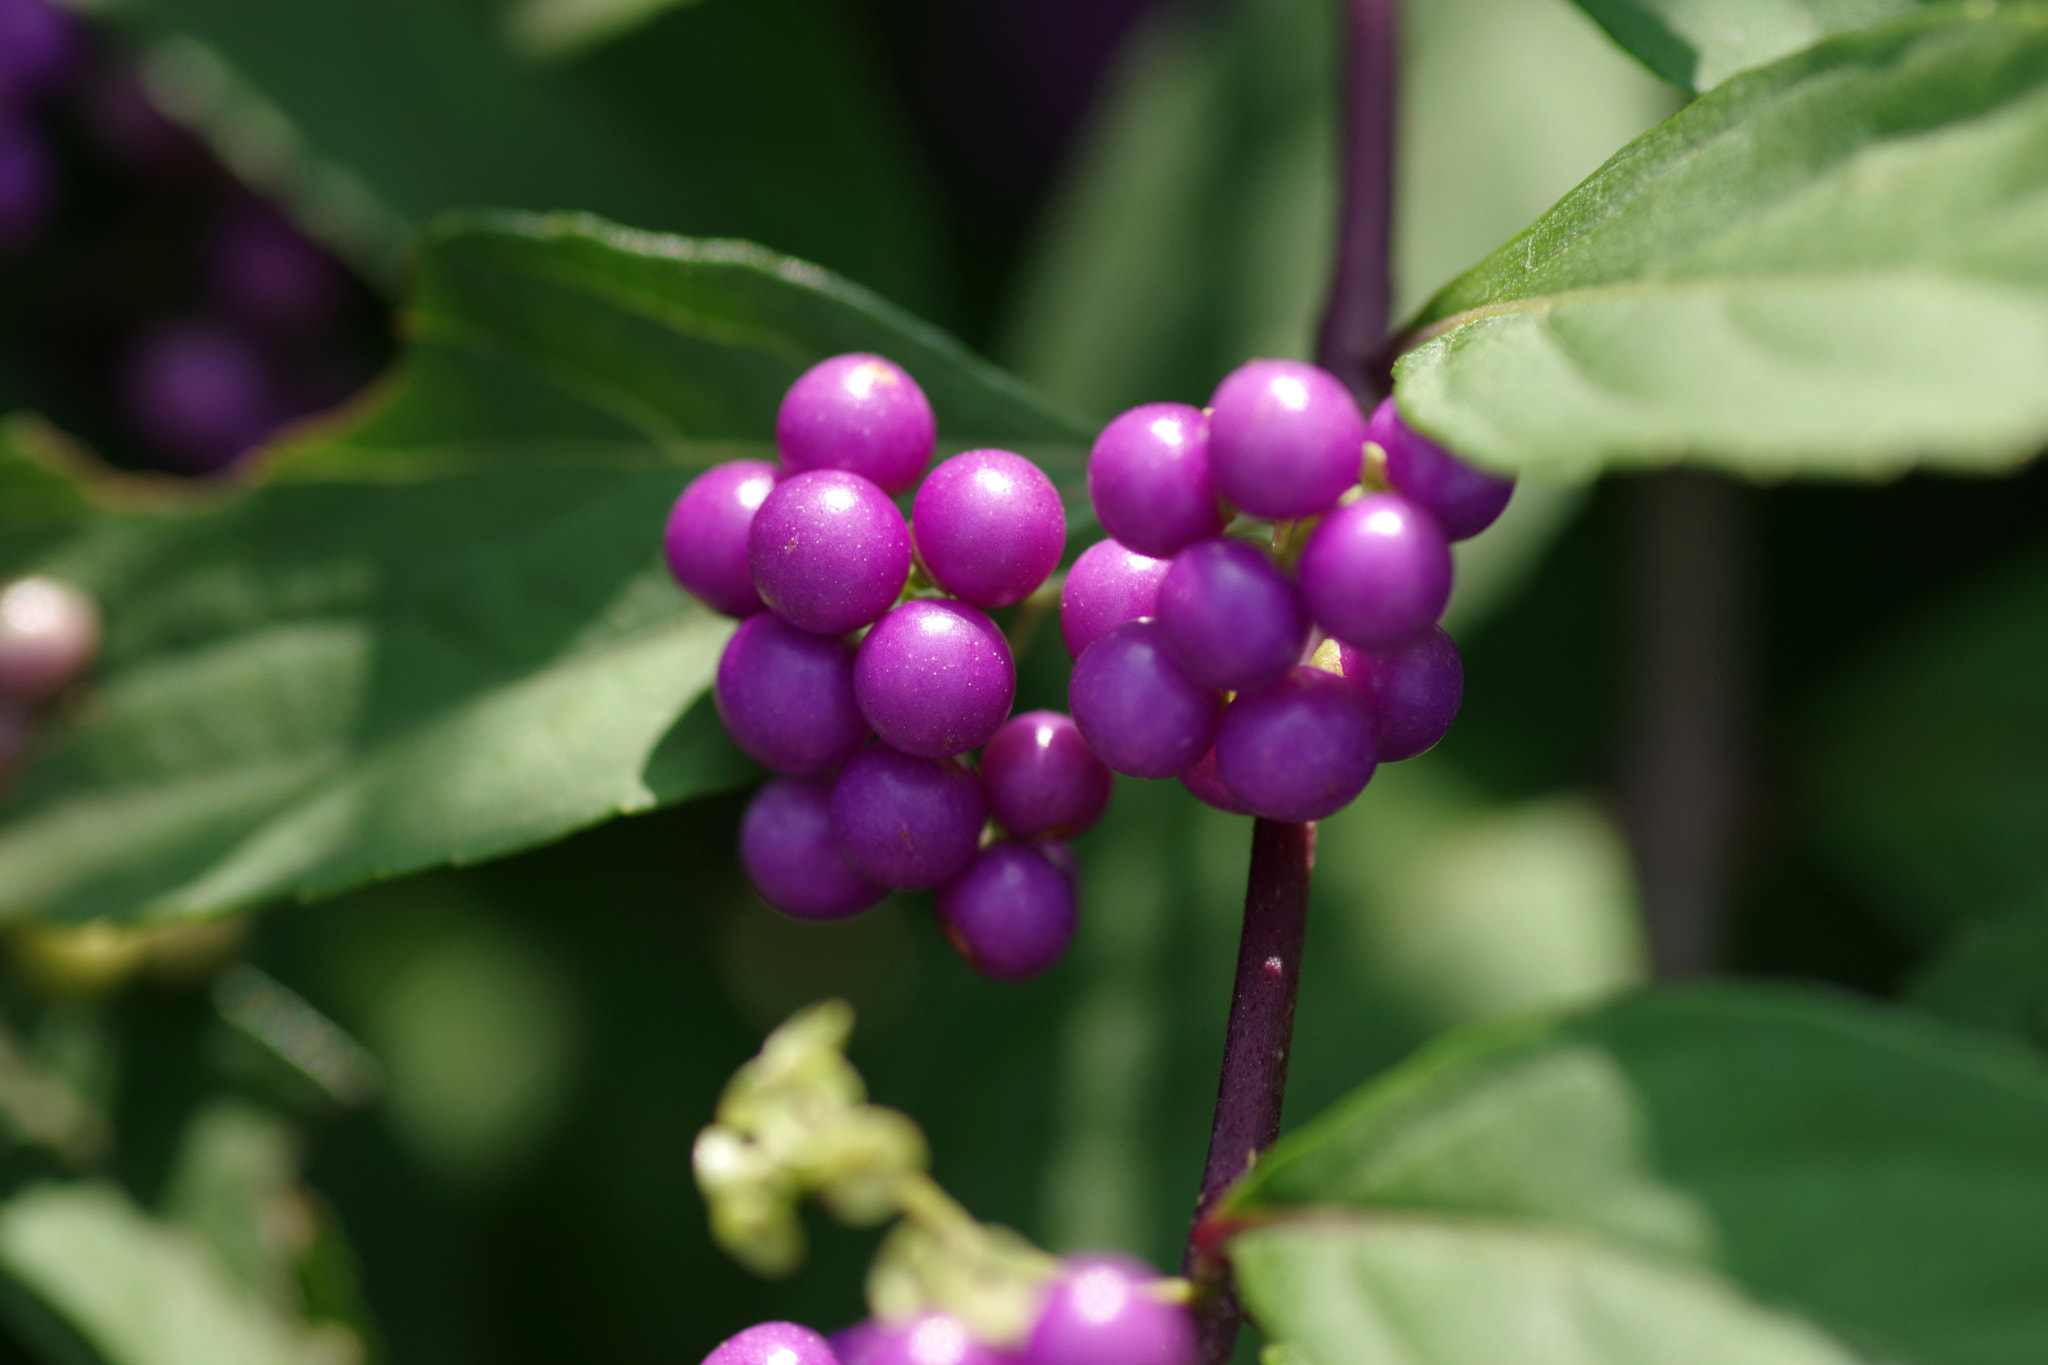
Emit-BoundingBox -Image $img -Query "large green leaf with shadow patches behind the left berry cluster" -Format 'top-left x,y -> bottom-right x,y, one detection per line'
0,219 -> 1081,919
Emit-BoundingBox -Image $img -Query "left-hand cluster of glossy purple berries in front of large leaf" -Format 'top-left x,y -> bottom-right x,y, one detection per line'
666,354 -> 1112,980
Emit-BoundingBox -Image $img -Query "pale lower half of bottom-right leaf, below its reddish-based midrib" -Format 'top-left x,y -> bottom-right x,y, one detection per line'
1231,1218 -> 1858,1365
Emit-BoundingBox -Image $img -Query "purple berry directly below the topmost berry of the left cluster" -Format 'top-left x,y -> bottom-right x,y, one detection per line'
748,469 -> 909,634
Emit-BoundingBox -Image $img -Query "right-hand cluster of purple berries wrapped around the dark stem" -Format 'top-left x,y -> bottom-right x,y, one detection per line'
1061,360 -> 1513,823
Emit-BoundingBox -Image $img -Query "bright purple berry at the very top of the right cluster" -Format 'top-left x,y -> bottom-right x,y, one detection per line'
1208,360 -> 1366,518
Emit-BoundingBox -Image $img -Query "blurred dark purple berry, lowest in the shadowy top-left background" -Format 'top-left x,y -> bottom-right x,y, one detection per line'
123,321 -> 276,475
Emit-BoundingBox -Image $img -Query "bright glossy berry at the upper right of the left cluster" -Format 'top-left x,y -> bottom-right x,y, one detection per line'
909,450 -> 1067,610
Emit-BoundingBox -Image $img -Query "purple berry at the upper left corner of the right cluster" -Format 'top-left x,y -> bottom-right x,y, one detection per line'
1087,403 -> 1225,559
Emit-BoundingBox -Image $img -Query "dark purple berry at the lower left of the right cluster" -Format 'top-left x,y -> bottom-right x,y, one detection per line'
1067,620 -> 1223,778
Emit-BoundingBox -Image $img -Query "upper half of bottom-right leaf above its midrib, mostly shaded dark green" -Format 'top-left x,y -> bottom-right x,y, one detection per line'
1225,986 -> 2048,1365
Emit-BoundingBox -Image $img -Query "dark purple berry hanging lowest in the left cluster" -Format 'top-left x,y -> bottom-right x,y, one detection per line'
936,843 -> 1075,980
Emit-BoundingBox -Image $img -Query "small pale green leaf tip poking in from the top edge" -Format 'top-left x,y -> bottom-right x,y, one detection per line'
1577,0 -> 1927,90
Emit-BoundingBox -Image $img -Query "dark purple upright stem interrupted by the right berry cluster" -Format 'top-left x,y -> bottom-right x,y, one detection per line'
1186,0 -> 1401,1365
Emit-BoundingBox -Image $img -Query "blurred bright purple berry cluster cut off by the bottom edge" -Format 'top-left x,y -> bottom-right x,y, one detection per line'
705,1257 -> 1196,1365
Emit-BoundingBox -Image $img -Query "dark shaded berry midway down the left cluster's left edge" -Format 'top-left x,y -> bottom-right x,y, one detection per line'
713,614 -> 868,774
